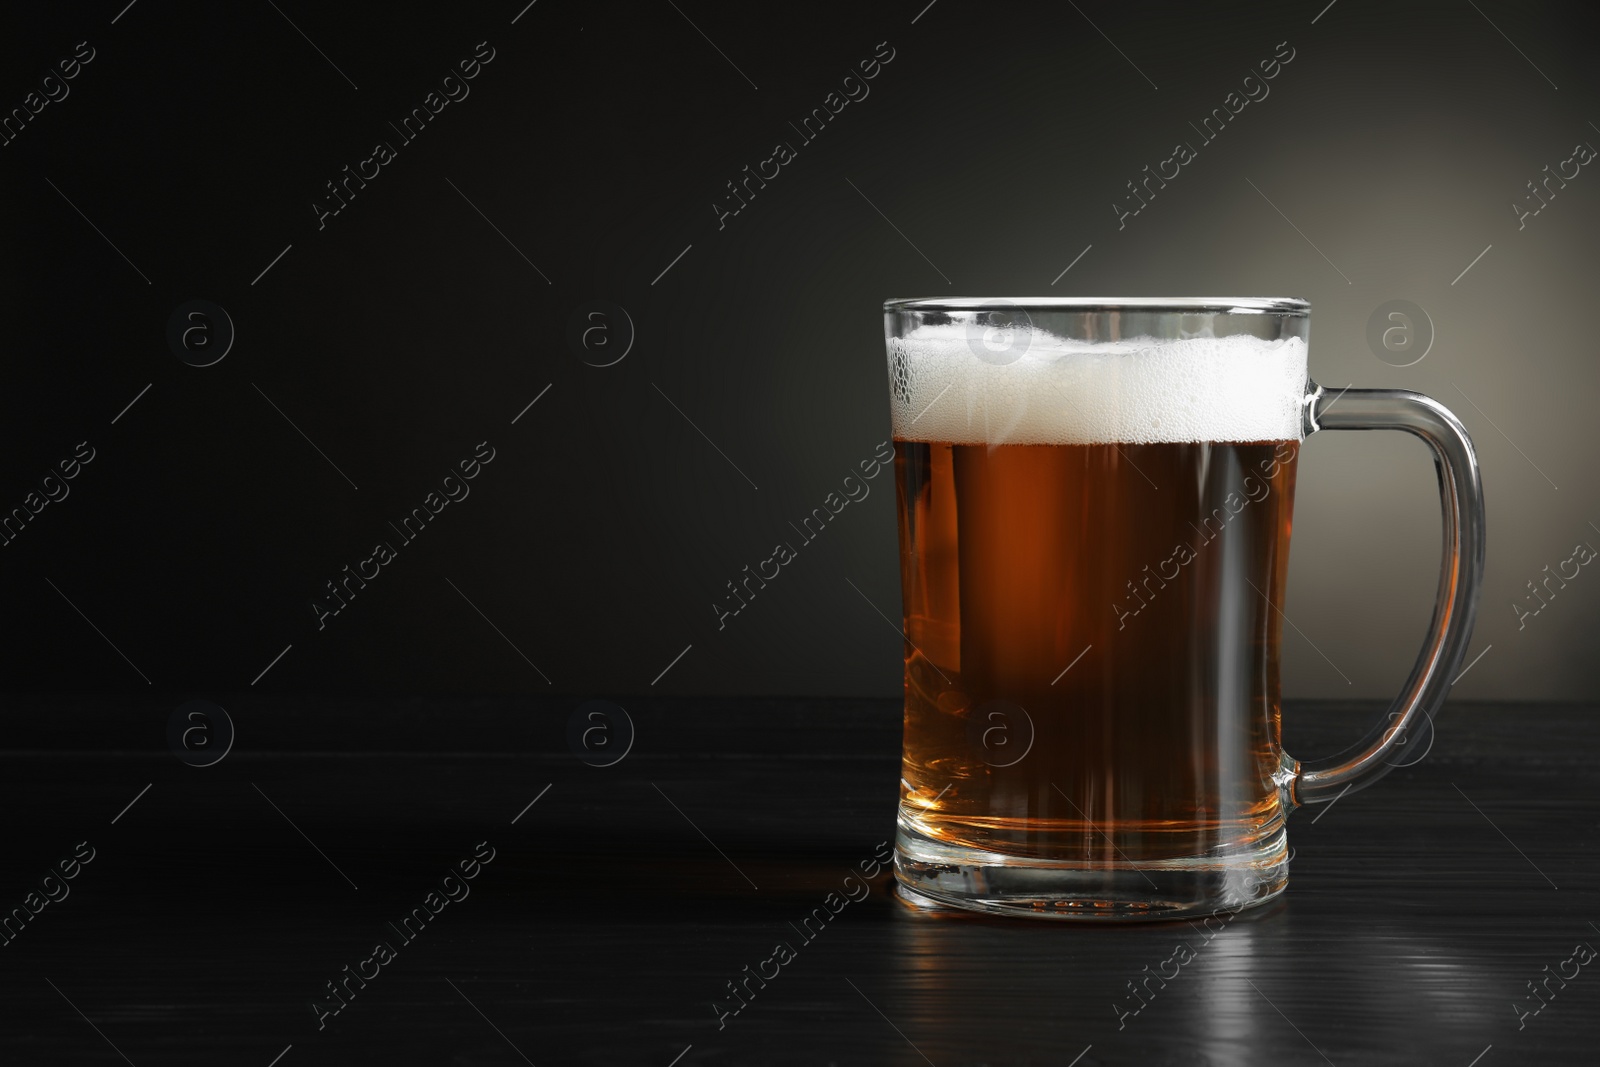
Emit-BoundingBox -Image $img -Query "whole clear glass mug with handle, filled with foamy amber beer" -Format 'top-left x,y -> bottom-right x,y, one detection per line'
883,298 -> 1483,920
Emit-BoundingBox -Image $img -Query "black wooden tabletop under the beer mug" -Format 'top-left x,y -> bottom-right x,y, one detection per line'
0,696 -> 1600,1067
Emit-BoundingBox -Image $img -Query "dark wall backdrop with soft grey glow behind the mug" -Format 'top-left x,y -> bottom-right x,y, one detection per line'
0,0 -> 1600,699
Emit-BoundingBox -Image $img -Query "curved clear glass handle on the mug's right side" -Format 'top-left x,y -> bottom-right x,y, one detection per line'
1293,382 -> 1483,803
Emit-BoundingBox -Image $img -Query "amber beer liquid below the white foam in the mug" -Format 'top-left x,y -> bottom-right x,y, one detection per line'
894,438 -> 1298,865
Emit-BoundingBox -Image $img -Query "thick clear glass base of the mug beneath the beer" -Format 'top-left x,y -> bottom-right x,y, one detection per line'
894,817 -> 1290,921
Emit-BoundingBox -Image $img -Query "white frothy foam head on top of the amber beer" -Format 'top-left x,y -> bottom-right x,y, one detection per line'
888,323 -> 1306,445
